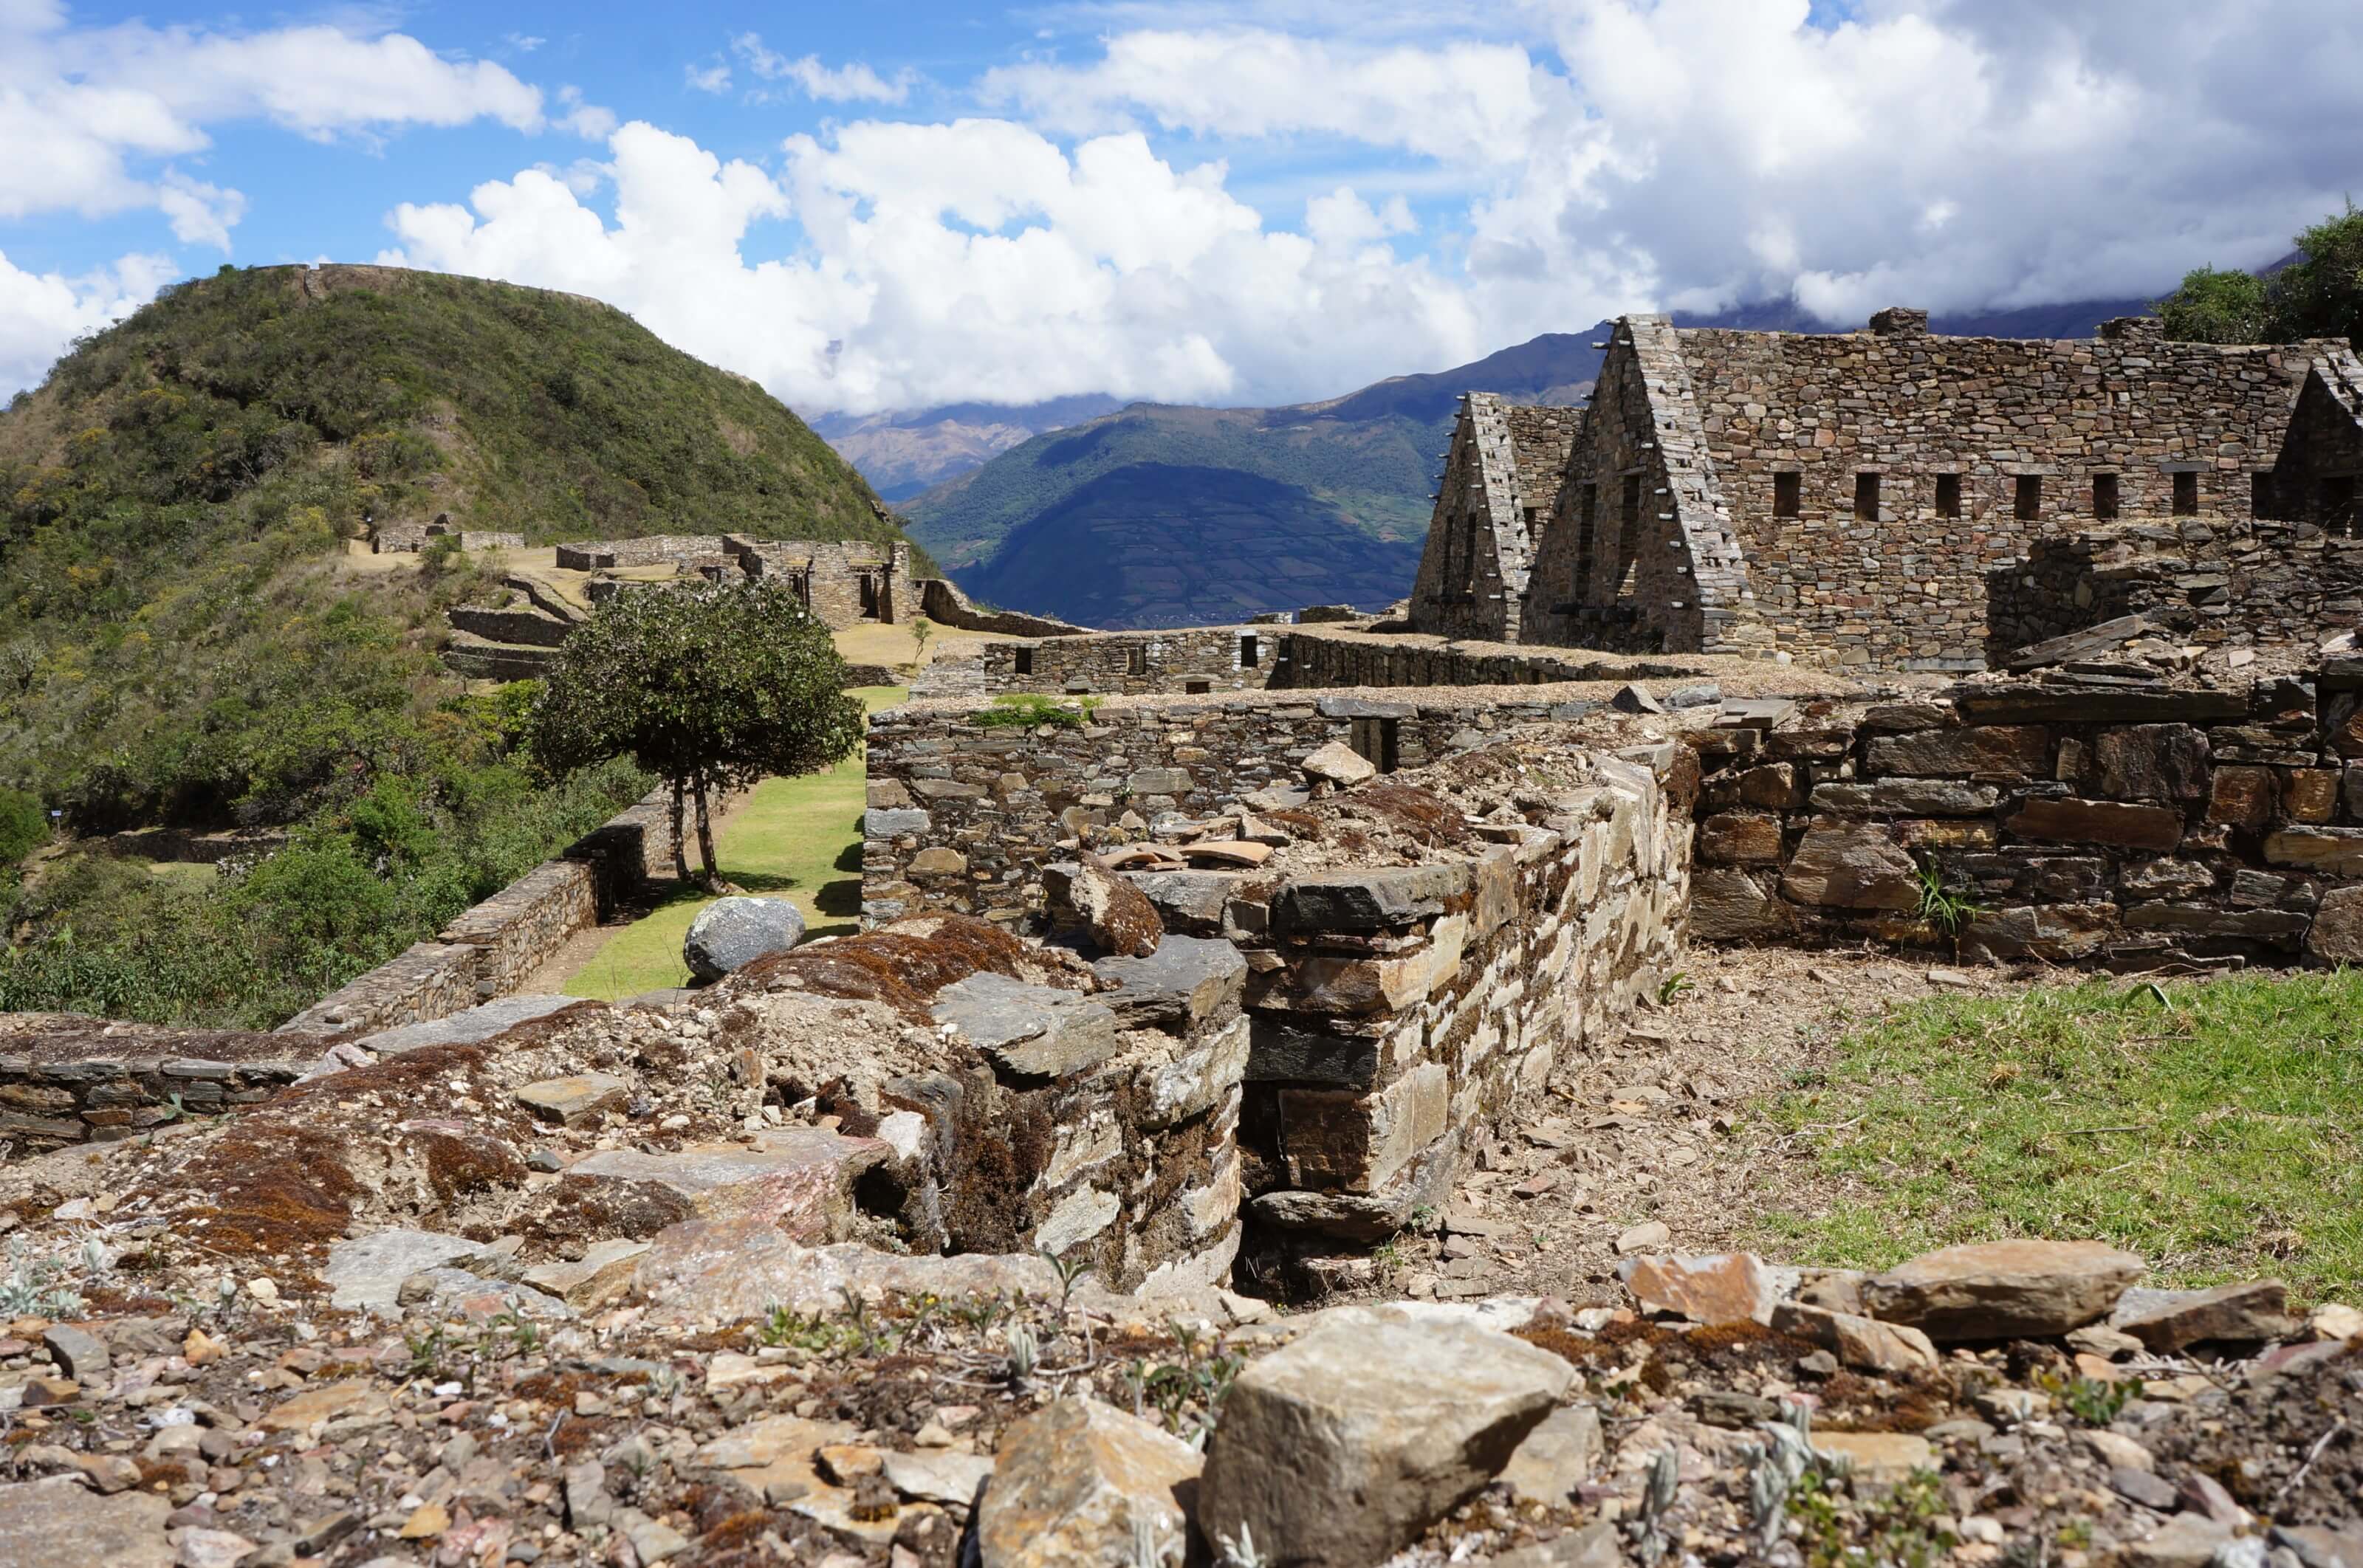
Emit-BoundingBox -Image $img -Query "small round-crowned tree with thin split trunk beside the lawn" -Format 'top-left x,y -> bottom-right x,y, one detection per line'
524,581 -> 862,881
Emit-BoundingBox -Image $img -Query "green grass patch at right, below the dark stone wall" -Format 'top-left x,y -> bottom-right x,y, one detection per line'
1760,971 -> 2363,1299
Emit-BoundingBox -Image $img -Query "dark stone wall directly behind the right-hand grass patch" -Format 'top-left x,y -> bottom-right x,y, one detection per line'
1690,659 -> 2363,971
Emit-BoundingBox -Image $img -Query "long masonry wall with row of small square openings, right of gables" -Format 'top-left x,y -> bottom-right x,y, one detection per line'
1680,312 -> 2316,670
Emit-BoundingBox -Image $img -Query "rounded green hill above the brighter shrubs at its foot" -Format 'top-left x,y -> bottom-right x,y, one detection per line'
0,267 -> 900,827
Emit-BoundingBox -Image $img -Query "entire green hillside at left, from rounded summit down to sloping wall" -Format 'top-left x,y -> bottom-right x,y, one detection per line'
0,267 -> 900,1025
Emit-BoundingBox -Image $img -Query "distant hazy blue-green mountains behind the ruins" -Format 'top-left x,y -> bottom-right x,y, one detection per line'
813,300 -> 2148,628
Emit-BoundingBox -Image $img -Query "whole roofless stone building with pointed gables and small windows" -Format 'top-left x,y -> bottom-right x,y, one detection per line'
1410,309 -> 2363,670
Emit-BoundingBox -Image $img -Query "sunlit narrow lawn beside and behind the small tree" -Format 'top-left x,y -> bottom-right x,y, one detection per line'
565,687 -> 908,1001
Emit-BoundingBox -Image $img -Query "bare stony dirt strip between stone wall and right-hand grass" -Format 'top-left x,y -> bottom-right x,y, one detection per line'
1371,947 -> 2028,1304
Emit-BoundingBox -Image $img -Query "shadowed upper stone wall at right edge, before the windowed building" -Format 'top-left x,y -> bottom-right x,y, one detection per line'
1987,517 -> 2363,661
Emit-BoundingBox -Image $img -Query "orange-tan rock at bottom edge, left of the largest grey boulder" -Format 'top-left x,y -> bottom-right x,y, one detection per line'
976,1398 -> 1200,1568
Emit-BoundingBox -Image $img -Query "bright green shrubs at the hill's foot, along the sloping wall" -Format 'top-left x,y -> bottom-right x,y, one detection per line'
0,727 -> 650,1030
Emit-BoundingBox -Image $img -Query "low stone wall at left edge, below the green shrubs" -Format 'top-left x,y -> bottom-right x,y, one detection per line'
0,1013 -> 317,1157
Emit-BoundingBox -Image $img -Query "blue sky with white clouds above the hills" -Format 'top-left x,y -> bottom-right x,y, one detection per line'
0,0 -> 2363,413
